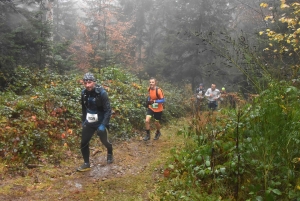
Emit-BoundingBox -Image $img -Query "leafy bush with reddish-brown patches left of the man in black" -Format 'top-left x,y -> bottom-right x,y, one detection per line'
0,67 -> 81,163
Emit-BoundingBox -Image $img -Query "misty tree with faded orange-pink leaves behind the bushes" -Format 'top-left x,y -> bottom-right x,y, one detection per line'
69,0 -> 135,72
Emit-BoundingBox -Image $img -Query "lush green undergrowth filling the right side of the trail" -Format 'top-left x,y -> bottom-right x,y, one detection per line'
152,81 -> 300,200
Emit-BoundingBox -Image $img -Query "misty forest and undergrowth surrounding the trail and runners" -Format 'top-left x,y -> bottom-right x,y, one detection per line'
0,0 -> 300,200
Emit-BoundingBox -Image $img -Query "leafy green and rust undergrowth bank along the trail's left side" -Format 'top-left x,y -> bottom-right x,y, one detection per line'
0,67 -> 190,173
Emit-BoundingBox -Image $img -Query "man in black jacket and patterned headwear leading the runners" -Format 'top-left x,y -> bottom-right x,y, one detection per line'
77,73 -> 114,172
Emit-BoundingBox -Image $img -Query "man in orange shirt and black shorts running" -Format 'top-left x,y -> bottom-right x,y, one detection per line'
144,78 -> 165,141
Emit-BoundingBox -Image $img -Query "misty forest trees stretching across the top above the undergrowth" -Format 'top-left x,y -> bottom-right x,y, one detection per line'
0,0 -> 299,93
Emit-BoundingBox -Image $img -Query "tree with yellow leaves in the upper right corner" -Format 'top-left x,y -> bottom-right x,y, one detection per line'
260,0 -> 300,80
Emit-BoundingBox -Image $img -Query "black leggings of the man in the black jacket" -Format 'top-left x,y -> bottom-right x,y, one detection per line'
80,125 -> 112,163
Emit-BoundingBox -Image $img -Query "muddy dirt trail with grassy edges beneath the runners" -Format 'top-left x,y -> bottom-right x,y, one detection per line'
0,121 -> 183,201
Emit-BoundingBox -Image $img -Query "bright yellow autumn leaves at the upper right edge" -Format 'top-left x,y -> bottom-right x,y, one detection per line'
259,0 -> 300,78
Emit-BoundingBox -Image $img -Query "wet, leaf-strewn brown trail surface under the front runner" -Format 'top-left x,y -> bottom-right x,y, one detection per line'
0,122 -> 182,201
